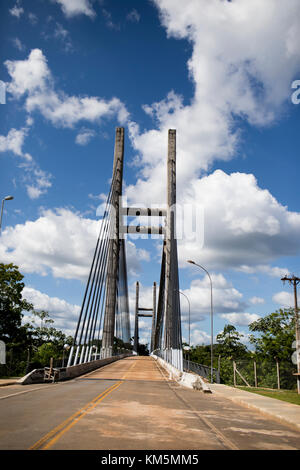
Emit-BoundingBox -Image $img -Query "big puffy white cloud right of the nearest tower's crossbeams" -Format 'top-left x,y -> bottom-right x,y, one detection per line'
178,170 -> 300,277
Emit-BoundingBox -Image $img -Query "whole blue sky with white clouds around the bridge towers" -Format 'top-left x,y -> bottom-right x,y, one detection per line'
0,0 -> 300,350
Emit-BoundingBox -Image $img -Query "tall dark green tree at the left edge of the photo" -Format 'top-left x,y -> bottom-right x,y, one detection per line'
0,263 -> 33,343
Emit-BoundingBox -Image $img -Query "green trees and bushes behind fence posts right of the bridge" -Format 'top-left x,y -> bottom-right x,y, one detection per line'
184,309 -> 296,390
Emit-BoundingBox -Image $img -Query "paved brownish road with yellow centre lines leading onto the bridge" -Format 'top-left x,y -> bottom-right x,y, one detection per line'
0,357 -> 300,450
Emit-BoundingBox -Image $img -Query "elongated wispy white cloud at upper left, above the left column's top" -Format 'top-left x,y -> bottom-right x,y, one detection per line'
5,49 -> 129,128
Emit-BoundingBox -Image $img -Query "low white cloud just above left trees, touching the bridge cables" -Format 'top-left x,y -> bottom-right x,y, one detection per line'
22,287 -> 80,335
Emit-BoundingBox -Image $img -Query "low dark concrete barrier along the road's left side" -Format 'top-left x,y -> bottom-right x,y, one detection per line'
16,354 -> 130,385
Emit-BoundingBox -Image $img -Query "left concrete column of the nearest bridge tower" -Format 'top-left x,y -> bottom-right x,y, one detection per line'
101,127 -> 124,358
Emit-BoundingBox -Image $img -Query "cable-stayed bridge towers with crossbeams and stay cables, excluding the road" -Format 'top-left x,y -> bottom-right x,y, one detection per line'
68,127 -> 183,370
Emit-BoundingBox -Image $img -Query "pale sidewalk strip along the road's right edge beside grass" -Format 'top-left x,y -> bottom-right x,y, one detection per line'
209,384 -> 300,431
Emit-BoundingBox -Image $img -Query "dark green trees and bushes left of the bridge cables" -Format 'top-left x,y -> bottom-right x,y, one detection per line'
0,263 -> 73,376
